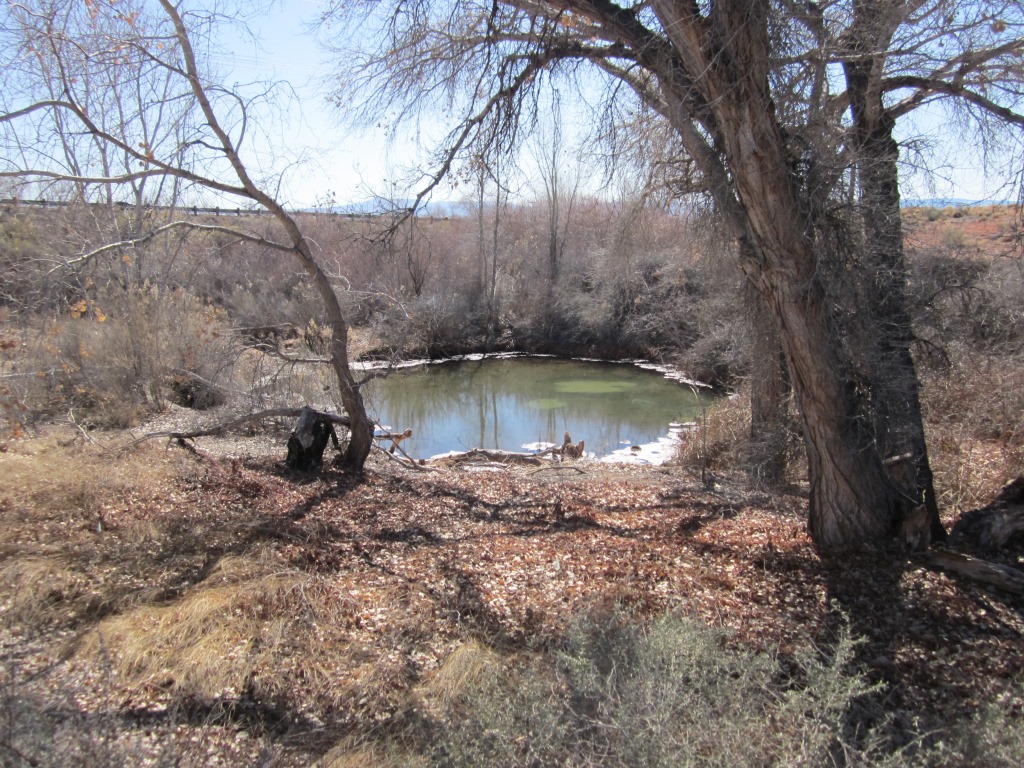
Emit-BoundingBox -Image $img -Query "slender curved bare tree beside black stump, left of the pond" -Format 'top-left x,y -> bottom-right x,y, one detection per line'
0,0 -> 373,469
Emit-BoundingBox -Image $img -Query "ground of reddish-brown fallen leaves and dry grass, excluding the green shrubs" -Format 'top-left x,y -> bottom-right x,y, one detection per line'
0,432 -> 1024,765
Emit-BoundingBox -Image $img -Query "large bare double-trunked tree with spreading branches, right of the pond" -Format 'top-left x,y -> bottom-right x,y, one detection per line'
332,0 -> 1024,553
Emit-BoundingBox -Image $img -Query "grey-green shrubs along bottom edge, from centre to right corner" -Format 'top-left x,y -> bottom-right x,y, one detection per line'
399,611 -> 1024,768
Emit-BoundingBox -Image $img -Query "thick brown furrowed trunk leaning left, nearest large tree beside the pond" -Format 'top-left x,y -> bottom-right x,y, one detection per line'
692,0 -> 897,554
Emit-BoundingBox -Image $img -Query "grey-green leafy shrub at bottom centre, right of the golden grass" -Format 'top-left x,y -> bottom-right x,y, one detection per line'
419,613 -> 870,768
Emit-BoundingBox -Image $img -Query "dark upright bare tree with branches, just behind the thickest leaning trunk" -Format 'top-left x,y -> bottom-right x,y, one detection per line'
835,0 -> 1024,539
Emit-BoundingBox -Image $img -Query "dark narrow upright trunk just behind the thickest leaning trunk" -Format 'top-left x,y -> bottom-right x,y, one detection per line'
846,59 -> 946,541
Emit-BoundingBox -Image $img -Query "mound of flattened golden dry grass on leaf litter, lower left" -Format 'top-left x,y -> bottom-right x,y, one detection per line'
78,552 -> 369,708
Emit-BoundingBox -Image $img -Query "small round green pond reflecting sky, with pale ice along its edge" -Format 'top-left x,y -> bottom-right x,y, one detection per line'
364,357 -> 701,463
